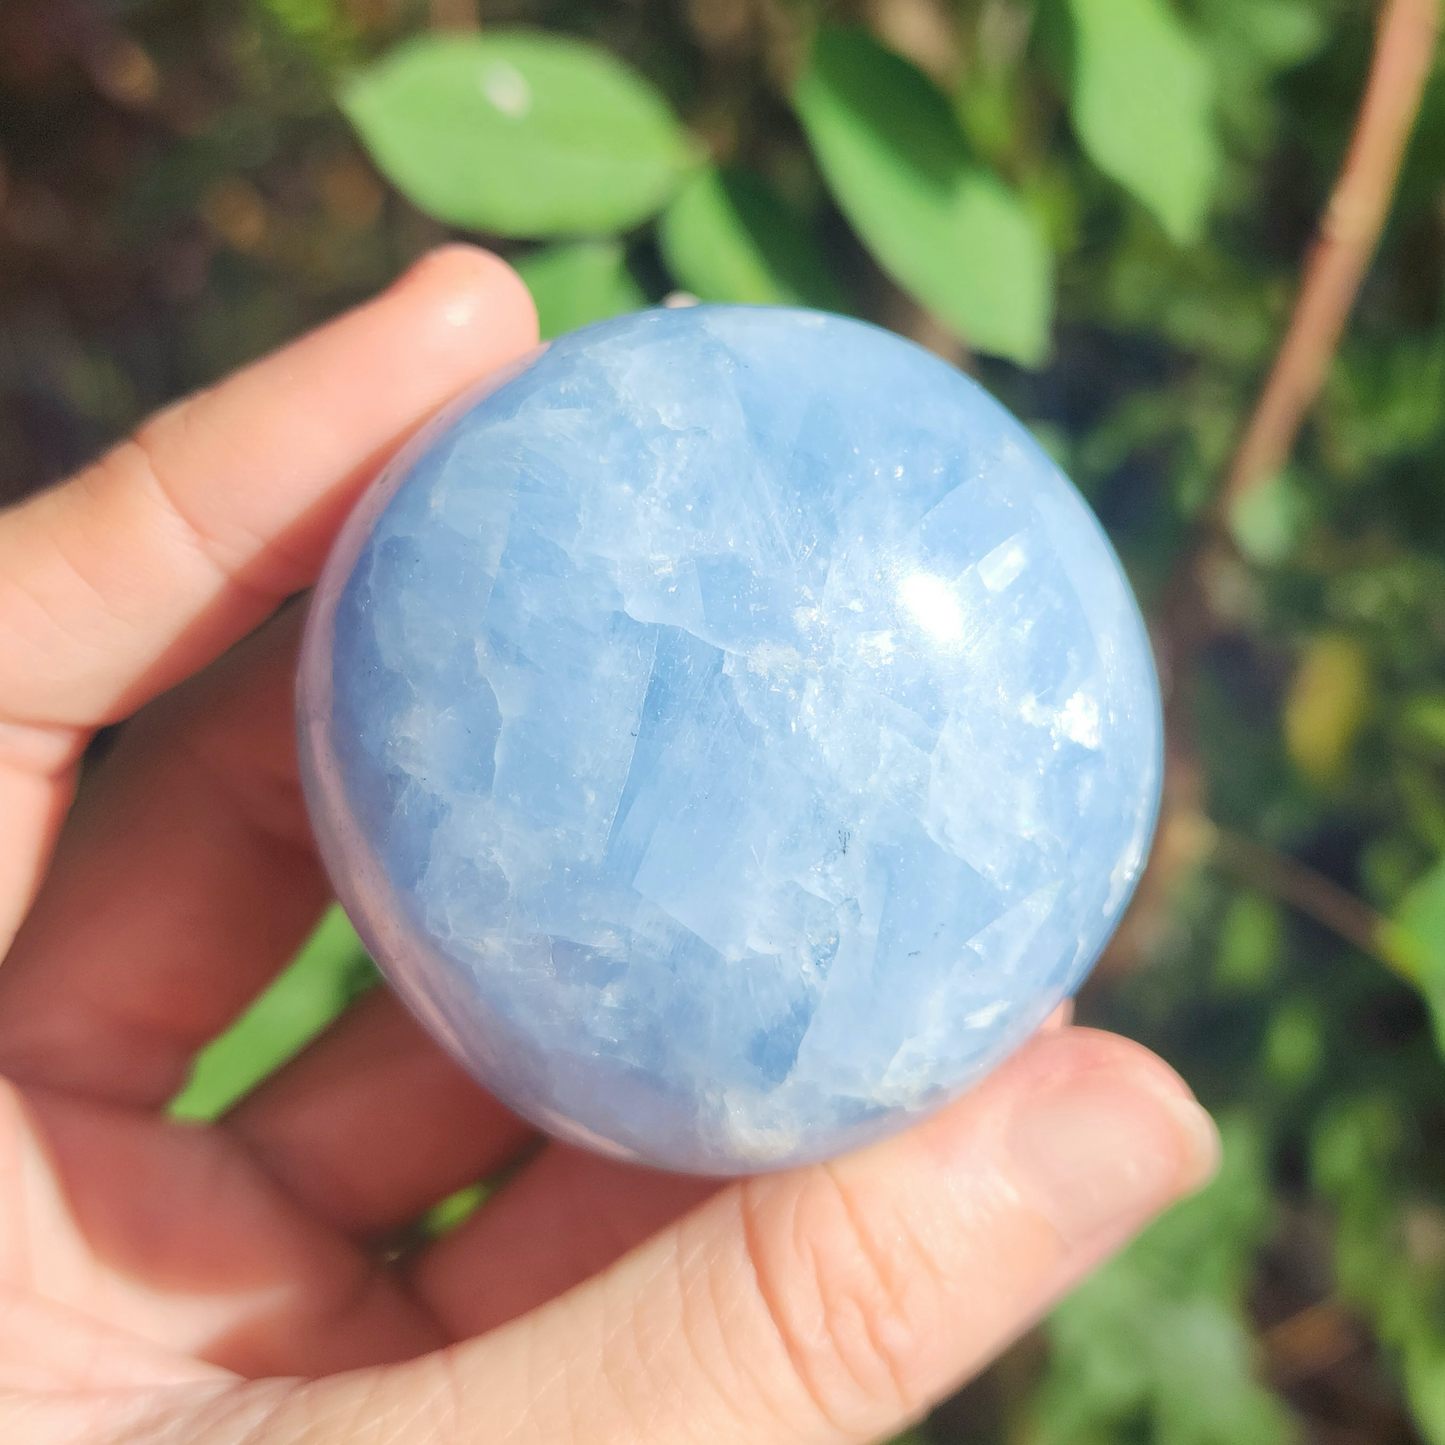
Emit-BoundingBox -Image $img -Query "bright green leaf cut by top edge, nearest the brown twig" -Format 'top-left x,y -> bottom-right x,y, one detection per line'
1069,0 -> 1220,244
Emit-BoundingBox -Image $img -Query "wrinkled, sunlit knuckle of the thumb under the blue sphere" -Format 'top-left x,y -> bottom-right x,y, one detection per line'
744,1165 -> 944,1433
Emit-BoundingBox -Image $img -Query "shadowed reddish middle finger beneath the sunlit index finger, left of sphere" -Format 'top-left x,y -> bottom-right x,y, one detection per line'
0,608 -> 329,1107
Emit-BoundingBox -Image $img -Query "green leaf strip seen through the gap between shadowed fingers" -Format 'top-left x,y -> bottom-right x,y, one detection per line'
171,906 -> 377,1120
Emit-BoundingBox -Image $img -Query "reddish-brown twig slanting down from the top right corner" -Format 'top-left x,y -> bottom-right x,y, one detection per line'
1221,0 -> 1441,517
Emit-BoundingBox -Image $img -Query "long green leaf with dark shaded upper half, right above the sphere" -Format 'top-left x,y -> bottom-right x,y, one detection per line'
793,29 -> 1053,366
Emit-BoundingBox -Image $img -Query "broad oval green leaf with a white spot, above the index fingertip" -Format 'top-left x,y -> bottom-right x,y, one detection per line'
341,32 -> 698,236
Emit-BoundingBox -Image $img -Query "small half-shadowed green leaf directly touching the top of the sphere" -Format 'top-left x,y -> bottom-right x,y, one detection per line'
657,169 -> 845,311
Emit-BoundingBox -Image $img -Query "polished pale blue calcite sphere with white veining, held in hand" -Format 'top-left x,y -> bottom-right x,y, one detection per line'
299,306 -> 1160,1173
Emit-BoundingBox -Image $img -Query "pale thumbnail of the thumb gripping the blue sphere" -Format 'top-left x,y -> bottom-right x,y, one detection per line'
1009,1072 -> 1220,1244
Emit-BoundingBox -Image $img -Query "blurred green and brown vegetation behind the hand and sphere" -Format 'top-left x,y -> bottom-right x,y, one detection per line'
0,0 -> 1445,1445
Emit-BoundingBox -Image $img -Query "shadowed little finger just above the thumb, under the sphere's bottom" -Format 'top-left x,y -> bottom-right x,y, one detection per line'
409,1144 -> 720,1340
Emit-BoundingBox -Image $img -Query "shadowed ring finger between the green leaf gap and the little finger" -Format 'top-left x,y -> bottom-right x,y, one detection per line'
224,990 -> 534,1236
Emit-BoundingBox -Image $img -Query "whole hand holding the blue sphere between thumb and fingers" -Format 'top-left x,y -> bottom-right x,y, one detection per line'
0,247 -> 1215,1445
